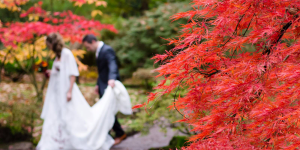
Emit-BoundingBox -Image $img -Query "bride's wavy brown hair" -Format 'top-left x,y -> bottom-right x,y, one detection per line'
46,33 -> 64,58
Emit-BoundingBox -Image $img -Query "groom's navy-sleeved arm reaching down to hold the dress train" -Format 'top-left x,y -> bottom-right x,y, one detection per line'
106,49 -> 118,80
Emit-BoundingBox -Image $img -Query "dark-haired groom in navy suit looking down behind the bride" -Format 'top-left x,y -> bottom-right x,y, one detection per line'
82,34 -> 126,145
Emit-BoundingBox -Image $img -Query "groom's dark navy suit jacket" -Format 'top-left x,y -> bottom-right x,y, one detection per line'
96,44 -> 120,96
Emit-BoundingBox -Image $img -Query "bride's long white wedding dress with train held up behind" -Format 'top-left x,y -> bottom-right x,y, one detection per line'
37,48 -> 132,150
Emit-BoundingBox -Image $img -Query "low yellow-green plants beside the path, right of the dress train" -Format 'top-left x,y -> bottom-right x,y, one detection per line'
119,80 -> 193,135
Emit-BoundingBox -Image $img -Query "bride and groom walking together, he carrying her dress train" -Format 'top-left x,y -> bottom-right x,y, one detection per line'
37,33 -> 132,150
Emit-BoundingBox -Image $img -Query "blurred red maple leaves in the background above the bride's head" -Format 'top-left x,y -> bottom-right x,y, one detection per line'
0,3 -> 117,46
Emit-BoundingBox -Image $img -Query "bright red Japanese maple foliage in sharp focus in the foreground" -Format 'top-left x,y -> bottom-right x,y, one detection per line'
141,0 -> 300,149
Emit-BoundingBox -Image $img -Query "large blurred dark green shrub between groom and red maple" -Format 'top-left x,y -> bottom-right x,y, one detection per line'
108,2 -> 190,77
